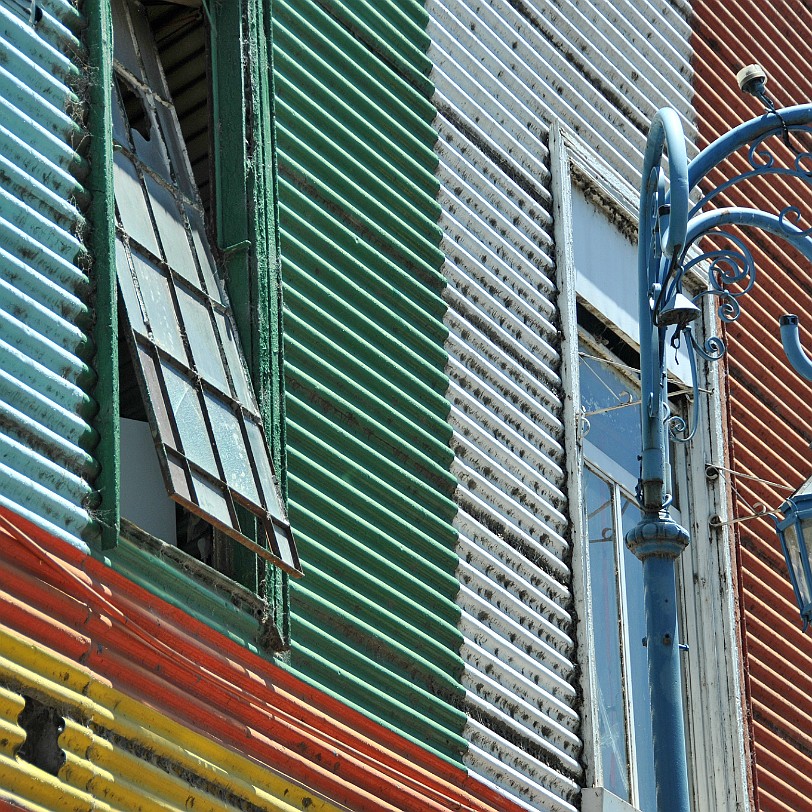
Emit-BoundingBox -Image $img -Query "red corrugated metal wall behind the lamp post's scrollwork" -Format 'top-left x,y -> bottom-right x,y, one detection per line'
694,0 -> 812,812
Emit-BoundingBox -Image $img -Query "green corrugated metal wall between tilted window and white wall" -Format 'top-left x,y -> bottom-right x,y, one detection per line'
274,0 -> 465,758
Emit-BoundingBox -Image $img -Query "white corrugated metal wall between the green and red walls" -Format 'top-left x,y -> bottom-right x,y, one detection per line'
427,0 -> 692,810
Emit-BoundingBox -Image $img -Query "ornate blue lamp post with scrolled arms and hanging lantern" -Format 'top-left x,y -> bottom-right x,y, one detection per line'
626,71 -> 812,812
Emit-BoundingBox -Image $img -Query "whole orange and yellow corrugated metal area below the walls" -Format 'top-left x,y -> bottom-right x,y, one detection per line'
0,511 -> 519,812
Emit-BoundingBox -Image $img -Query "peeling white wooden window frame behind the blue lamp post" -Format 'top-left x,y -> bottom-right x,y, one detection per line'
550,121 -> 752,812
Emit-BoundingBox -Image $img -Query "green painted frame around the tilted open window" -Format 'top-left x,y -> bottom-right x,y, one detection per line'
86,0 -> 290,648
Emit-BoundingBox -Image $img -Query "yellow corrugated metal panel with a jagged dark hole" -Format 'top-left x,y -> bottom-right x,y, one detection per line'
0,627 -> 343,812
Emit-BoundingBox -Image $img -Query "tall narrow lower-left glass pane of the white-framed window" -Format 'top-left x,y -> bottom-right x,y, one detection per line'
584,470 -> 630,801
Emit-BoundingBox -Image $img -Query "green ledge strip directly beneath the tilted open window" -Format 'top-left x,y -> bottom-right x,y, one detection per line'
98,519 -> 286,656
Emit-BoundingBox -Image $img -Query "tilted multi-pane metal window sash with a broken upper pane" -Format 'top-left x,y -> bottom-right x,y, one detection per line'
113,2 -> 301,573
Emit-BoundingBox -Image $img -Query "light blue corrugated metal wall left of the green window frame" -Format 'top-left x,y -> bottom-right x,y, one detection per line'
0,0 -> 98,547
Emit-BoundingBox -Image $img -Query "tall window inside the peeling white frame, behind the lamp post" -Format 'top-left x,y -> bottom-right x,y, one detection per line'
572,188 -> 689,812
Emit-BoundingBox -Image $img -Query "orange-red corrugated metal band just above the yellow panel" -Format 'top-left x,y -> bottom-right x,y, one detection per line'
0,513 -> 518,812
